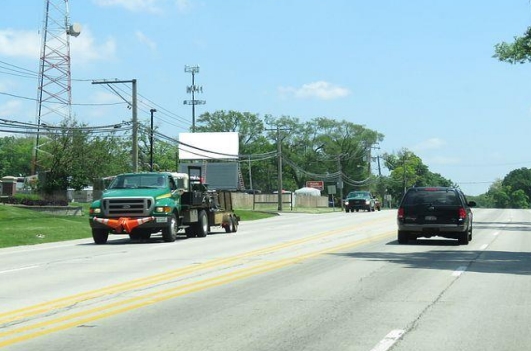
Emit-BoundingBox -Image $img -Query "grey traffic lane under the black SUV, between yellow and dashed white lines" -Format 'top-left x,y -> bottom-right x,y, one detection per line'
1,210 -> 512,350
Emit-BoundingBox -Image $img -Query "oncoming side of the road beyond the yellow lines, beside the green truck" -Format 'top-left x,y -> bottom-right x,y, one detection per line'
0,211 -> 393,312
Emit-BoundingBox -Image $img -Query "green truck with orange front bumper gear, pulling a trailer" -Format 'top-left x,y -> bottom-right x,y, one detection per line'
89,167 -> 240,244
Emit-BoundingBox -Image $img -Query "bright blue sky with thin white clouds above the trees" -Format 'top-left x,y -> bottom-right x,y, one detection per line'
0,0 -> 531,195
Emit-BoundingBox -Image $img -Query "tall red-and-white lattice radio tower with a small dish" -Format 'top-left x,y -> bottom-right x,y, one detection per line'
32,0 -> 81,174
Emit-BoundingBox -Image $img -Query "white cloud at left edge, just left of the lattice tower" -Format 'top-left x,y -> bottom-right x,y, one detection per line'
0,29 -> 41,59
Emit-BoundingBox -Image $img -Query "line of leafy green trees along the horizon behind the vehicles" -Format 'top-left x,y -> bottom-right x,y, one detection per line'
0,111 -> 531,208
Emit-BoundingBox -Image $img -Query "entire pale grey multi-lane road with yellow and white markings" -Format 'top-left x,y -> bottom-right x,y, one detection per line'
0,209 -> 531,351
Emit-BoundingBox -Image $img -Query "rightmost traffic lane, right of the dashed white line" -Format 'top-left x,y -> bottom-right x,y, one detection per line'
393,210 -> 531,351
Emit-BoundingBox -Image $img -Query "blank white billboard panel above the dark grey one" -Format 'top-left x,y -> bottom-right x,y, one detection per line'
179,132 -> 240,160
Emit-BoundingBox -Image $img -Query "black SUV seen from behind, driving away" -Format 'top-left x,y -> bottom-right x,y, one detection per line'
397,187 -> 476,245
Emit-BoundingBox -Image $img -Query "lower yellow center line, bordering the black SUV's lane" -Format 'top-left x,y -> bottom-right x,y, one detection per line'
0,231 -> 395,347
